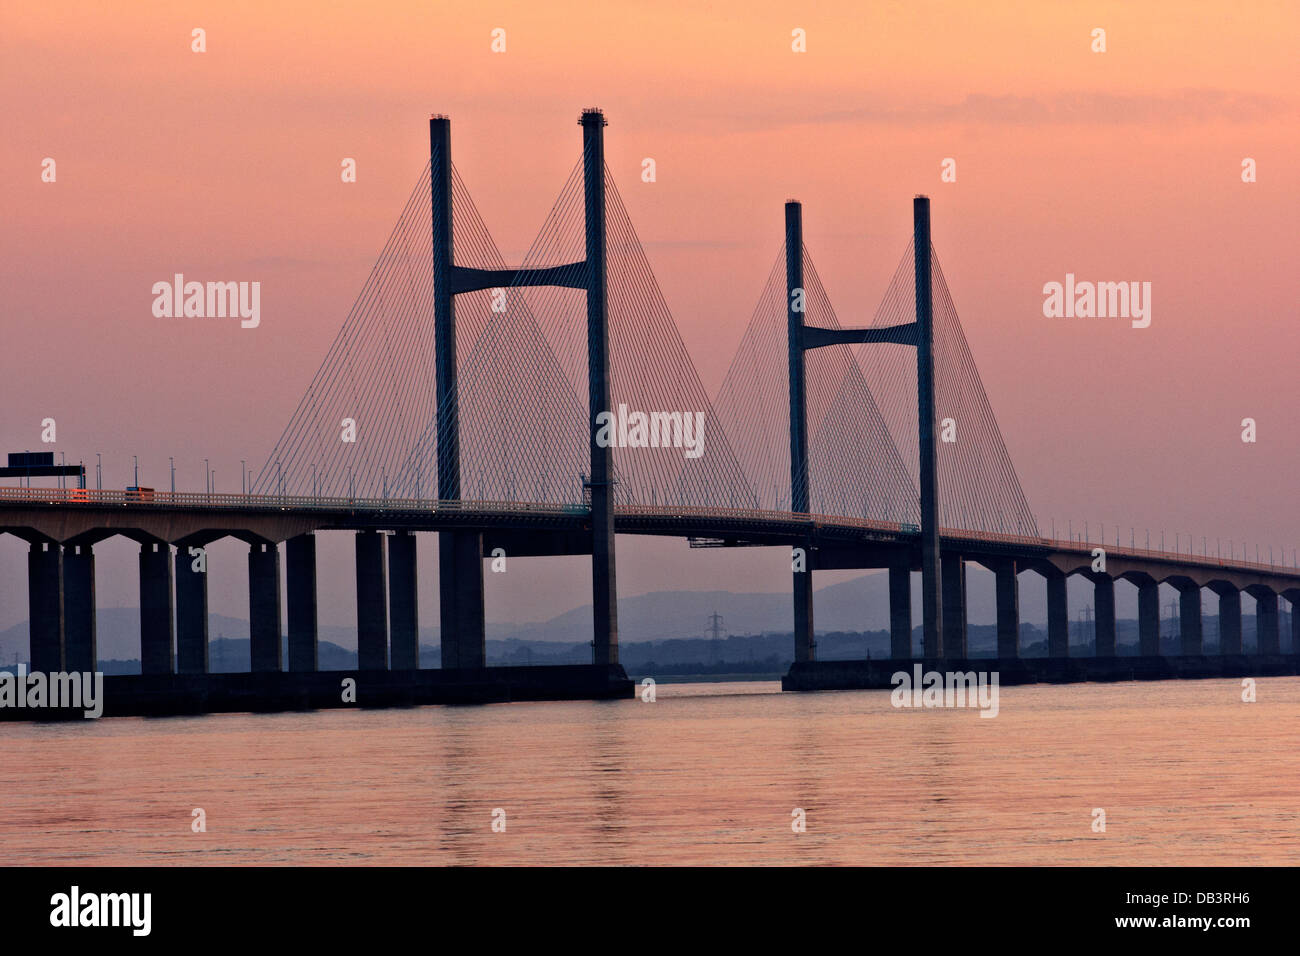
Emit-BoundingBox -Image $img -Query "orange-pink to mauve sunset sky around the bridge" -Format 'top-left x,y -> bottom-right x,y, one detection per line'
0,0 -> 1300,627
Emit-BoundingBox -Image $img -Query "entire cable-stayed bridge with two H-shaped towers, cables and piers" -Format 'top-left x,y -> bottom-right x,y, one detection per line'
0,109 -> 1300,713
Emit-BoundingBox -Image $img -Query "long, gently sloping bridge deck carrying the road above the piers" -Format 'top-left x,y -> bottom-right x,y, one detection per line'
0,488 -> 1300,593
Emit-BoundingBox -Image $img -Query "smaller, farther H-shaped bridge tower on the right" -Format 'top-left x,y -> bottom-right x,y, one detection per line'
785,196 -> 941,661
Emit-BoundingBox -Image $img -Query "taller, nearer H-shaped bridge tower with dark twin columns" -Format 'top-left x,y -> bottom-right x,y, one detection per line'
429,109 -> 619,669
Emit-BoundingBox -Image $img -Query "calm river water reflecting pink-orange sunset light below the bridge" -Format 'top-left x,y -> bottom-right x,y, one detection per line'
0,678 -> 1300,865
